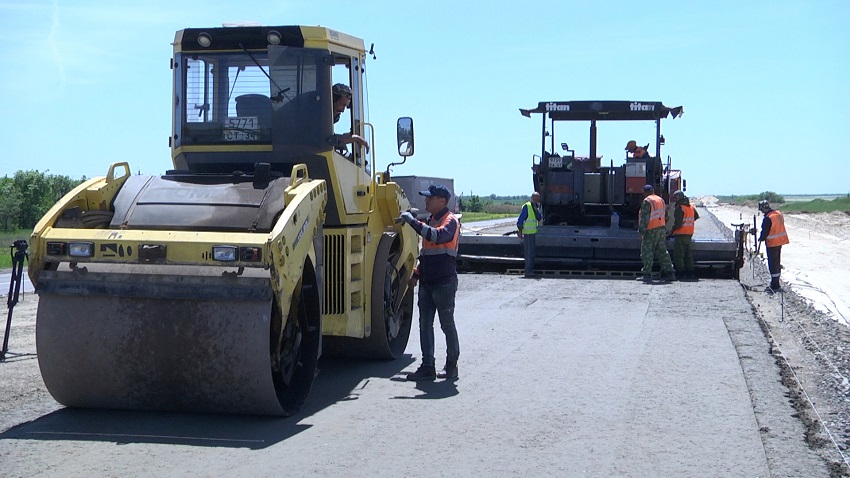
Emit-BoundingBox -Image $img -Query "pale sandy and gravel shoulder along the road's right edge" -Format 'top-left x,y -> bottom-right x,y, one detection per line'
698,197 -> 850,476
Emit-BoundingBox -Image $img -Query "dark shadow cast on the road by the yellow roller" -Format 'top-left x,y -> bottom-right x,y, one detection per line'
0,355 -> 413,449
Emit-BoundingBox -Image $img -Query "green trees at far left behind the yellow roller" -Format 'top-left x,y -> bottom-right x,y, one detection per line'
0,171 -> 86,231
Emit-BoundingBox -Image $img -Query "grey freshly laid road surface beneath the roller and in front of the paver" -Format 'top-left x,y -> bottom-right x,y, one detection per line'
0,275 -> 829,477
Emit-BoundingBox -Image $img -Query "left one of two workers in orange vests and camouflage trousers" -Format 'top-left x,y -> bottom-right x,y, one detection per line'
637,184 -> 676,282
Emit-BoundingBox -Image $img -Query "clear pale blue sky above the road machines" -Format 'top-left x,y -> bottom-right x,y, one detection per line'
0,0 -> 850,195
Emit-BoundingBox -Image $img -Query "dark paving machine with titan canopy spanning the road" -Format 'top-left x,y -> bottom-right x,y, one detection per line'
458,101 -> 740,277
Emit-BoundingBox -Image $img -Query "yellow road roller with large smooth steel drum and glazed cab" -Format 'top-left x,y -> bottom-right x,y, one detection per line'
29,26 -> 418,415
